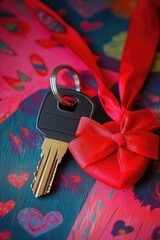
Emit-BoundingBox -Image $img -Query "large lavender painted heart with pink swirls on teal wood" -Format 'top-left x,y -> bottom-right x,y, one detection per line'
18,208 -> 63,237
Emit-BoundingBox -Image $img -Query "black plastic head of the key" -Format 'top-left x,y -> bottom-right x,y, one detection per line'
37,89 -> 95,142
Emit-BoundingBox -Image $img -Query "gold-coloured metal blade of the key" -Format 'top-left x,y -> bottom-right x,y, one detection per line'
31,138 -> 68,197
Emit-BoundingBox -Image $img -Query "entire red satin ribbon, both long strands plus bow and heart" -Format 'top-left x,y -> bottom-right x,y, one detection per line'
25,0 -> 160,189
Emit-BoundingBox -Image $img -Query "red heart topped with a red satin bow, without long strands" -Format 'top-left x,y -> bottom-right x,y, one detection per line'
69,109 -> 159,189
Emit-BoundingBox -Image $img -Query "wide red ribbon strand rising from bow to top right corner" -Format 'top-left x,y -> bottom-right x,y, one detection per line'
119,0 -> 160,110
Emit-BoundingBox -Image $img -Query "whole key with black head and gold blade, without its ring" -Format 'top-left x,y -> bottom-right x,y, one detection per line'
31,89 -> 95,197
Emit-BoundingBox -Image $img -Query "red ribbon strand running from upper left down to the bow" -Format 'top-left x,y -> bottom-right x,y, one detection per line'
25,0 -> 122,121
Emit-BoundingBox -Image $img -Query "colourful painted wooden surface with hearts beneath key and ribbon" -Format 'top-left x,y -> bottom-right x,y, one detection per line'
0,0 -> 160,240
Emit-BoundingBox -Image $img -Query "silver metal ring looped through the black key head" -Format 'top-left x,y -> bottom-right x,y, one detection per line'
50,65 -> 81,107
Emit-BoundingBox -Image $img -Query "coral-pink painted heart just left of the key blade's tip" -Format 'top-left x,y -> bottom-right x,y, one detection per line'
8,172 -> 30,189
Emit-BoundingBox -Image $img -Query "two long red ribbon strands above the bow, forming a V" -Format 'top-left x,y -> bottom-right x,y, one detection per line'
24,0 -> 160,121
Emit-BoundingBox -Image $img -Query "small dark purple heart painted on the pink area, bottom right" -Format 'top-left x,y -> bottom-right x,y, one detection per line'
111,220 -> 134,237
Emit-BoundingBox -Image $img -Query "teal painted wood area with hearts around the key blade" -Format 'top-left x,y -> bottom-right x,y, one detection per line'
0,90 -> 95,240
